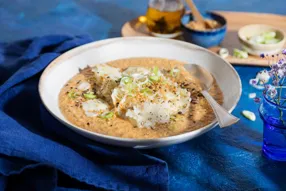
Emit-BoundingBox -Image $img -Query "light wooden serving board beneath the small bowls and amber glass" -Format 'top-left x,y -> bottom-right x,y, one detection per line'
121,11 -> 286,66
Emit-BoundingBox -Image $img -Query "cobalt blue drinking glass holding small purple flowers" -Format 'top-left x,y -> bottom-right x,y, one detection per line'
259,96 -> 286,161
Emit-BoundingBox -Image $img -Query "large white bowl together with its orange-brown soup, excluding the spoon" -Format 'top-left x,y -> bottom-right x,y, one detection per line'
39,37 -> 241,148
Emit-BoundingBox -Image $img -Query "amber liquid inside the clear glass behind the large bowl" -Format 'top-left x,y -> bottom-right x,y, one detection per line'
146,6 -> 184,34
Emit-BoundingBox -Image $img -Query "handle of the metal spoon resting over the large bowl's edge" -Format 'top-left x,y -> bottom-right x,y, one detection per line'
201,90 -> 239,128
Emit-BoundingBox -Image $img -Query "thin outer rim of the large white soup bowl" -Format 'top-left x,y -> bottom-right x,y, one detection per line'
38,37 -> 242,144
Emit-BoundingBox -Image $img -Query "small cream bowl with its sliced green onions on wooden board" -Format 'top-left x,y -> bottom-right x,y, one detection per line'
238,24 -> 286,56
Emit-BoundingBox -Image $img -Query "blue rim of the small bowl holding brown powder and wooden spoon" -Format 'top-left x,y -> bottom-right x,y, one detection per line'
181,11 -> 227,34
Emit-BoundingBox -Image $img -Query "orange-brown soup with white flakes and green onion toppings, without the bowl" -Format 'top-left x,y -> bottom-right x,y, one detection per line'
59,58 -> 223,139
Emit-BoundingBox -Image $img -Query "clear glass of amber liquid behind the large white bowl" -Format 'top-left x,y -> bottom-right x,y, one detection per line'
146,0 -> 185,38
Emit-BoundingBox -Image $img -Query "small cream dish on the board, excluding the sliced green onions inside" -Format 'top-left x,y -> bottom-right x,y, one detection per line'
238,24 -> 286,56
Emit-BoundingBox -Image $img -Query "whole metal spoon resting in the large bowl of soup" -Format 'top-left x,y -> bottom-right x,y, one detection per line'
184,64 -> 239,127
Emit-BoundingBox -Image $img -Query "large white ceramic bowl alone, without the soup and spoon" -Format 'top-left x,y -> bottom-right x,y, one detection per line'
39,37 -> 241,148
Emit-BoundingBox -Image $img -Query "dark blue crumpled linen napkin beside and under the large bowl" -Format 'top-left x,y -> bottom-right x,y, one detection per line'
0,35 -> 168,191
